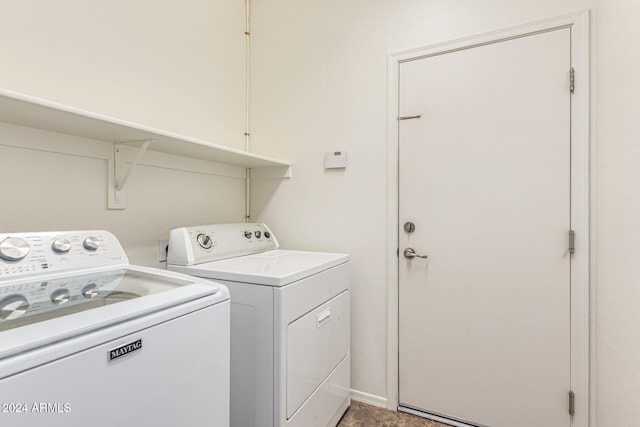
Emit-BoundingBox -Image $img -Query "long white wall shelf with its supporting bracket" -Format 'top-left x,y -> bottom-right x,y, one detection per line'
0,89 -> 291,209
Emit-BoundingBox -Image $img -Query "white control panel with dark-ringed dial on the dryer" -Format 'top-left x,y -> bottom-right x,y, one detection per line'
167,223 -> 278,265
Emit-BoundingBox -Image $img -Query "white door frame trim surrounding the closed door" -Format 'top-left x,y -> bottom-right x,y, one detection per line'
386,10 -> 593,427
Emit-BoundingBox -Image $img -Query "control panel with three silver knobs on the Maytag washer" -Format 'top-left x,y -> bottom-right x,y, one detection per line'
0,230 -> 129,282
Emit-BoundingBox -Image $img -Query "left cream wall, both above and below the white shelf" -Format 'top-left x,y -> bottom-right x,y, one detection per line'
0,0 -> 246,265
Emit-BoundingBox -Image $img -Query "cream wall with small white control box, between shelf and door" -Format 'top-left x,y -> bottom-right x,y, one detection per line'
251,0 -> 596,412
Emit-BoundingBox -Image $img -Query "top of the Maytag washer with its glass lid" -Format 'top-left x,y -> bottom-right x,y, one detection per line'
0,266 -> 229,360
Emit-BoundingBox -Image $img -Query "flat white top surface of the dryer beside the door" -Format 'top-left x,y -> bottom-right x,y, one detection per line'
168,249 -> 349,286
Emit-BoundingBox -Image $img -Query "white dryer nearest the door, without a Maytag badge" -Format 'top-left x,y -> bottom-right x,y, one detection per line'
167,223 -> 351,427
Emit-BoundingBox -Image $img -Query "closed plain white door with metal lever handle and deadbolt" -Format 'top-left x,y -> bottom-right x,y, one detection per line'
398,28 -> 571,427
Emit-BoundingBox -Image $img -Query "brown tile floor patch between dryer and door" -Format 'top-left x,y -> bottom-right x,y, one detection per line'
337,400 -> 449,427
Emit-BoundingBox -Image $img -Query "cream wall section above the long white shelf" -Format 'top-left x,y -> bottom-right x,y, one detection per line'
0,0 -> 245,148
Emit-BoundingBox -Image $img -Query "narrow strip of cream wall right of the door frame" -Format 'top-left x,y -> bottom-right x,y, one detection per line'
593,0 -> 640,427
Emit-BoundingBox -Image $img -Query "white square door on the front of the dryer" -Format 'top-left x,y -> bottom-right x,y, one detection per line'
286,291 -> 349,419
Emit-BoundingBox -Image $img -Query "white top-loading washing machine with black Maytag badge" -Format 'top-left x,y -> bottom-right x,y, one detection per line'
0,230 -> 230,427
